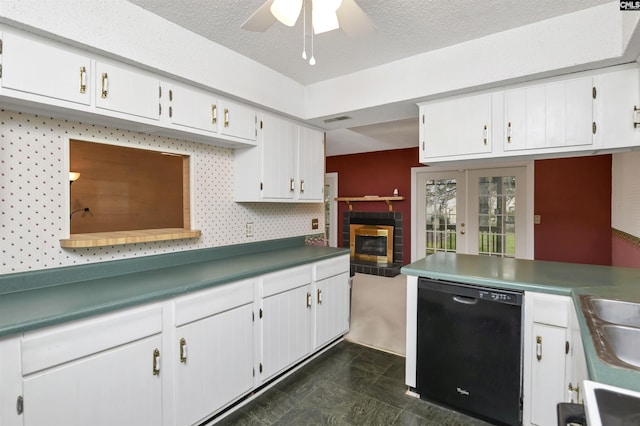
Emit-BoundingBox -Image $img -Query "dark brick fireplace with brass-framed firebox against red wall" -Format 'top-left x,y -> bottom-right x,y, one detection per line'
342,211 -> 403,277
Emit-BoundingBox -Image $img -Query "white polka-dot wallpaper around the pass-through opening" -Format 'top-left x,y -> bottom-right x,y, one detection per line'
0,109 -> 324,274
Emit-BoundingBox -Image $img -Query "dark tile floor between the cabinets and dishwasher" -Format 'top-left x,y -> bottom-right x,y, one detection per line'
216,341 -> 487,426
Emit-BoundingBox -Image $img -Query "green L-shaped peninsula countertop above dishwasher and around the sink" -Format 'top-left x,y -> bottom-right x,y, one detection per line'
401,253 -> 640,391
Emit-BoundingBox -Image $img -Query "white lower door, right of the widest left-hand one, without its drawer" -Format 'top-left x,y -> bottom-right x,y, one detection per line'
175,304 -> 253,425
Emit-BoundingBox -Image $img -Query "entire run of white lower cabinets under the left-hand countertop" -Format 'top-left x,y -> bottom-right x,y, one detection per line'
0,255 -> 350,426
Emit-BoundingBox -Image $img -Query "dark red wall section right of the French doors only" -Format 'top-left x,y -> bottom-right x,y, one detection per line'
534,155 -> 611,265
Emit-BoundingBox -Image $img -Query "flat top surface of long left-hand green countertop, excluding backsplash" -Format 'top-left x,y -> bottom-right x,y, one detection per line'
0,245 -> 349,337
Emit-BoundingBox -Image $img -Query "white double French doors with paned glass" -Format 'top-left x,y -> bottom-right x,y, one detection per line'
412,166 -> 533,260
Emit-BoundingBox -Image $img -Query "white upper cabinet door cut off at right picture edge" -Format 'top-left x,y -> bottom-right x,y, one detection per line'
593,68 -> 640,148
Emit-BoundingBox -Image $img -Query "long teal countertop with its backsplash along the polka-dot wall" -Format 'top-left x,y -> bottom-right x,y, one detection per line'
0,240 -> 349,337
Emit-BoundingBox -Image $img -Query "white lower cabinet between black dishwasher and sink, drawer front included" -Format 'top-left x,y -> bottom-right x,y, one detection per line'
523,292 -> 586,426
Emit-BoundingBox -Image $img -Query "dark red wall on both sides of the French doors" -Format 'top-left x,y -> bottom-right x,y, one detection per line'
326,147 -> 612,265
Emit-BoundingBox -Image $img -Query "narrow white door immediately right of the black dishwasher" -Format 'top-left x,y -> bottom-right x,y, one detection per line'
530,323 -> 567,426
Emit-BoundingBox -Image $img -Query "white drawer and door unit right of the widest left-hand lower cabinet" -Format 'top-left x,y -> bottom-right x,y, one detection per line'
171,280 -> 254,425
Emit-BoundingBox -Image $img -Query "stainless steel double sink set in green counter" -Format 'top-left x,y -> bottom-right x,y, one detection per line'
580,296 -> 640,371
